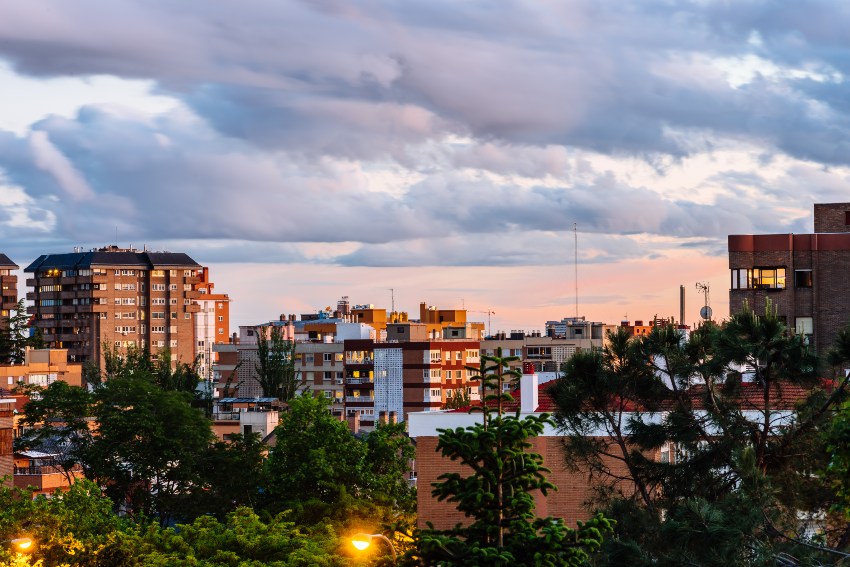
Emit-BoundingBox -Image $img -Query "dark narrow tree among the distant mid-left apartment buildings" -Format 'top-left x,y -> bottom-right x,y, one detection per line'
254,325 -> 302,402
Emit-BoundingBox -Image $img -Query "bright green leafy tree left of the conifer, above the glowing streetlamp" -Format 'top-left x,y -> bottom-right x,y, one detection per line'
263,395 -> 416,544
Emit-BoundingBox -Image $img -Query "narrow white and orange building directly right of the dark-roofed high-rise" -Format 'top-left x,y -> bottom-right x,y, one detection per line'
195,268 -> 230,380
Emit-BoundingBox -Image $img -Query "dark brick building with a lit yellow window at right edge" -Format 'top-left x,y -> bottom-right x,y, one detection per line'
729,203 -> 850,352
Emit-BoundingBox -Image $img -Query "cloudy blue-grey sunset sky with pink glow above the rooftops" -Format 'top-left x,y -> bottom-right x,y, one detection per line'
0,0 -> 850,332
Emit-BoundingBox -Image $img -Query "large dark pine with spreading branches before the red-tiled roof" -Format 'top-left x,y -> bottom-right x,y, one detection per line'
550,309 -> 844,565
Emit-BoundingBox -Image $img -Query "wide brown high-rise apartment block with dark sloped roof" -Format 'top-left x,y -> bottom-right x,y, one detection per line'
24,246 -> 202,364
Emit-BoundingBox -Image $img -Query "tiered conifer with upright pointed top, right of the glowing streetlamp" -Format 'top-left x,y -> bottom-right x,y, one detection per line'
418,352 -> 612,566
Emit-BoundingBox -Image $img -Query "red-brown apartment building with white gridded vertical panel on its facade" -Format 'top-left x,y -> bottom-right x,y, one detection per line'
344,323 -> 479,429
